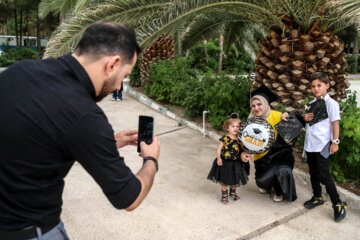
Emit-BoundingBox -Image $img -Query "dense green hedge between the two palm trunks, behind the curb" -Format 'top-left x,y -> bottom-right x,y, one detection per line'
145,58 -> 251,129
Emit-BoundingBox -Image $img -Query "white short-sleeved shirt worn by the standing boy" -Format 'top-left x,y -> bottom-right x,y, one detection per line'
304,94 -> 340,152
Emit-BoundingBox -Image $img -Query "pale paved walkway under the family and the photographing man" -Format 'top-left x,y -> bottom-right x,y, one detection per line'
62,92 -> 360,240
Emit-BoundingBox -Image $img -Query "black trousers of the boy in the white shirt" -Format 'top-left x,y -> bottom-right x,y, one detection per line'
306,152 -> 340,205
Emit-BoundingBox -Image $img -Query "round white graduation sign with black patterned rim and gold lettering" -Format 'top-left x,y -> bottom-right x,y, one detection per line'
239,117 -> 275,153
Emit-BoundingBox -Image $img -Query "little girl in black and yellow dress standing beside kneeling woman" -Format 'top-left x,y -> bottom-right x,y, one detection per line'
207,113 -> 249,204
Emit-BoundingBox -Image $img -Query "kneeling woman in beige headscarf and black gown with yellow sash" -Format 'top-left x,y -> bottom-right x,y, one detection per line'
248,90 -> 297,202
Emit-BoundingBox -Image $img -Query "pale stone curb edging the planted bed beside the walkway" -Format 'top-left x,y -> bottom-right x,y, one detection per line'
124,83 -> 360,213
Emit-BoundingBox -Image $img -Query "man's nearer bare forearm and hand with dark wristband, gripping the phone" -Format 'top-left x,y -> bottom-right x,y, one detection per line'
126,136 -> 160,211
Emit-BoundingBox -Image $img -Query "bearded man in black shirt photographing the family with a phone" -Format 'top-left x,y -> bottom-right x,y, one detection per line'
0,22 -> 160,240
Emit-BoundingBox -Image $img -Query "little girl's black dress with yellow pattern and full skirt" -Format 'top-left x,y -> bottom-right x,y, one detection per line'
207,134 -> 250,186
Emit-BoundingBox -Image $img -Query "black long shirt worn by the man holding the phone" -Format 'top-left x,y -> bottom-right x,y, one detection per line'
0,55 -> 141,230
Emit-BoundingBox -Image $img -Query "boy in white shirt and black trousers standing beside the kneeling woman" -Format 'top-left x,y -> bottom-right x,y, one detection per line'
304,72 -> 347,222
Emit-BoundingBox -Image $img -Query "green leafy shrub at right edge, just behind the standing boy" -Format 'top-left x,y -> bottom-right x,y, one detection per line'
329,91 -> 360,182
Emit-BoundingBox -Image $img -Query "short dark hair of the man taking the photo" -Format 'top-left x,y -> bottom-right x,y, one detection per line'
75,22 -> 141,63
